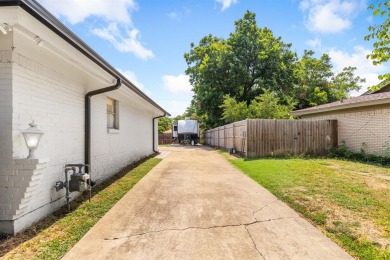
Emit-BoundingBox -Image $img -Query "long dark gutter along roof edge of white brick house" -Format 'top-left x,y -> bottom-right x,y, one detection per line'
0,0 -> 170,115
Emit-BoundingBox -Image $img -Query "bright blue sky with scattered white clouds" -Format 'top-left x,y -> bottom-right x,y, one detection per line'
38,0 -> 388,116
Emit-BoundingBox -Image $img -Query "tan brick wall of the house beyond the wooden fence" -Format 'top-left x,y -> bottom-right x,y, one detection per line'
302,104 -> 390,156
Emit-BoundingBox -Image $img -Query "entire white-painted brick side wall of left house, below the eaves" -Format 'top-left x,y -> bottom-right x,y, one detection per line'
0,27 -> 158,233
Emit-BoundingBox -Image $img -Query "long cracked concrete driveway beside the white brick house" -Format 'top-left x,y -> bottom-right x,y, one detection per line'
64,147 -> 352,260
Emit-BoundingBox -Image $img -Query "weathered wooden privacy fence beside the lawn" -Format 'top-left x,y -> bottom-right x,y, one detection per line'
205,119 -> 337,157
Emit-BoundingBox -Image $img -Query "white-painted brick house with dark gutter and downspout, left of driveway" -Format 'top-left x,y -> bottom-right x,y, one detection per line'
0,0 -> 168,234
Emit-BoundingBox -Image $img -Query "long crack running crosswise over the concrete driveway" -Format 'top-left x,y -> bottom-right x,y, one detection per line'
103,218 -> 291,240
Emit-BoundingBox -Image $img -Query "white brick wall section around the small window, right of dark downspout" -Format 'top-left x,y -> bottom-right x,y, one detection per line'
91,93 -> 153,179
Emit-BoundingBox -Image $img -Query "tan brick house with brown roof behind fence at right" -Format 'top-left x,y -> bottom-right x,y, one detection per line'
290,89 -> 390,156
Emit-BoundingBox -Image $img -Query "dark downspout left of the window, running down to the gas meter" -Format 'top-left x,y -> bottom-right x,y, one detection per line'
84,78 -> 122,173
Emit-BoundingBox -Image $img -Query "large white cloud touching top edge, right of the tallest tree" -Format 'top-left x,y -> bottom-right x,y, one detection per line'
299,0 -> 366,33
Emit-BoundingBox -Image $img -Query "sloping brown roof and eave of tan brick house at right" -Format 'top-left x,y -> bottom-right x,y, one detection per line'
290,92 -> 390,116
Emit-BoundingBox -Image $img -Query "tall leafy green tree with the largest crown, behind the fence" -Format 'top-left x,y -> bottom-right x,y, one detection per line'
184,11 -> 296,127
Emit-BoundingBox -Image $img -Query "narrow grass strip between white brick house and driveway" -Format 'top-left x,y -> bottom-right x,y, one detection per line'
0,155 -> 161,259
